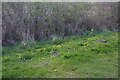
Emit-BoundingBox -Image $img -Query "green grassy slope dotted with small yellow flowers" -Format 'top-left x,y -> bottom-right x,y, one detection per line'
2,32 -> 120,78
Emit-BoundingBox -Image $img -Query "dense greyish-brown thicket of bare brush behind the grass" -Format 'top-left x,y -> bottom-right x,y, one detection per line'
2,2 -> 119,45
